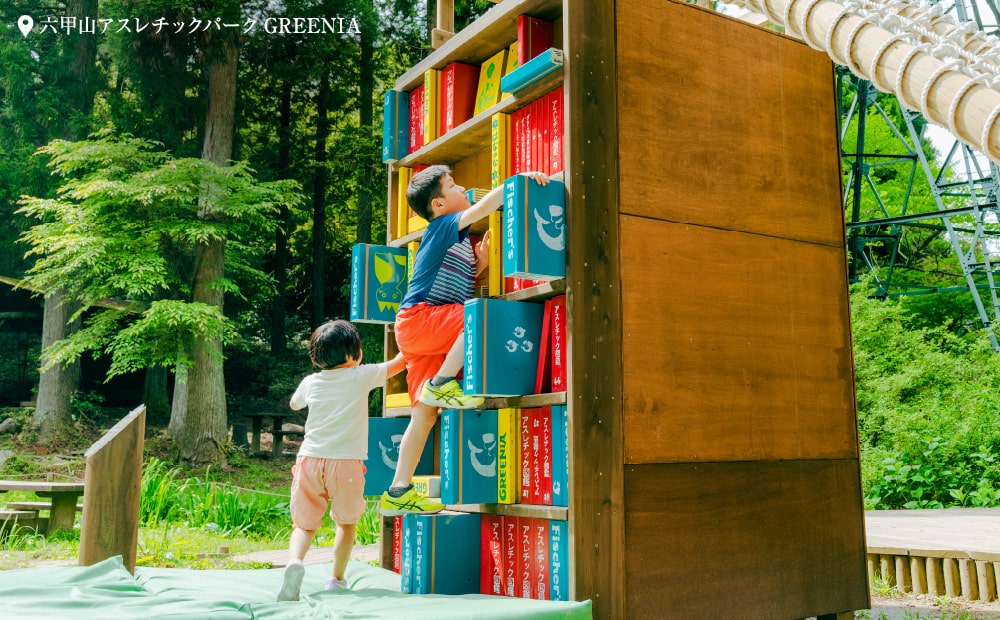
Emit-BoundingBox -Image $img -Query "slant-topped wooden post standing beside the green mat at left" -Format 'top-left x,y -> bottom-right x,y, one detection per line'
79,405 -> 146,572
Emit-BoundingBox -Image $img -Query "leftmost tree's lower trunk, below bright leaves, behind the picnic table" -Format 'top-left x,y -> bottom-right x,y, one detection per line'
31,290 -> 80,444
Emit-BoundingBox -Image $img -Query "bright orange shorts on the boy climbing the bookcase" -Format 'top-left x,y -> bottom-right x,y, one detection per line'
396,302 -> 465,403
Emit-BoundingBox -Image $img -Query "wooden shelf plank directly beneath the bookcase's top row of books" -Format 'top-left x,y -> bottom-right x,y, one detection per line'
392,71 -> 563,170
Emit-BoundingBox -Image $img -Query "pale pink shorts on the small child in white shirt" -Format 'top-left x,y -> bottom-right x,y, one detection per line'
290,456 -> 366,530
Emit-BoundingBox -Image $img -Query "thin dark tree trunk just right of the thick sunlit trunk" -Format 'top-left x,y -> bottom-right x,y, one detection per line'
271,81 -> 292,358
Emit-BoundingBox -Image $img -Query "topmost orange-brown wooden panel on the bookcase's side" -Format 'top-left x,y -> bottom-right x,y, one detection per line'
618,0 -> 844,245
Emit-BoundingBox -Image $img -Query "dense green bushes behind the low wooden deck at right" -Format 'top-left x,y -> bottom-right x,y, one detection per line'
851,284 -> 1000,508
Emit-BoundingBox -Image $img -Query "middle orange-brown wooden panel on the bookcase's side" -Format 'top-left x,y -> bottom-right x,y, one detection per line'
621,216 -> 858,463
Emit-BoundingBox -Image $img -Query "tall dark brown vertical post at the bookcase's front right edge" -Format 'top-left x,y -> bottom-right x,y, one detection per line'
568,0 -> 628,620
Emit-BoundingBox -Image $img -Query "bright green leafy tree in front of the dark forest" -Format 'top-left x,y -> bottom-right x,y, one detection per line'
20,132 -> 298,460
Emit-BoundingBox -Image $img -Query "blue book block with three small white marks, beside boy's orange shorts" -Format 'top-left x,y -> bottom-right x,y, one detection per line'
463,298 -> 543,396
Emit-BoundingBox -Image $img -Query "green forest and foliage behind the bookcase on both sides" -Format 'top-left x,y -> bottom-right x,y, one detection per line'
0,0 -> 1000,520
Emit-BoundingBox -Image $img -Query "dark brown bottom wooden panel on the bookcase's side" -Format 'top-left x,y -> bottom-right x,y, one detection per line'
625,459 -> 870,620
